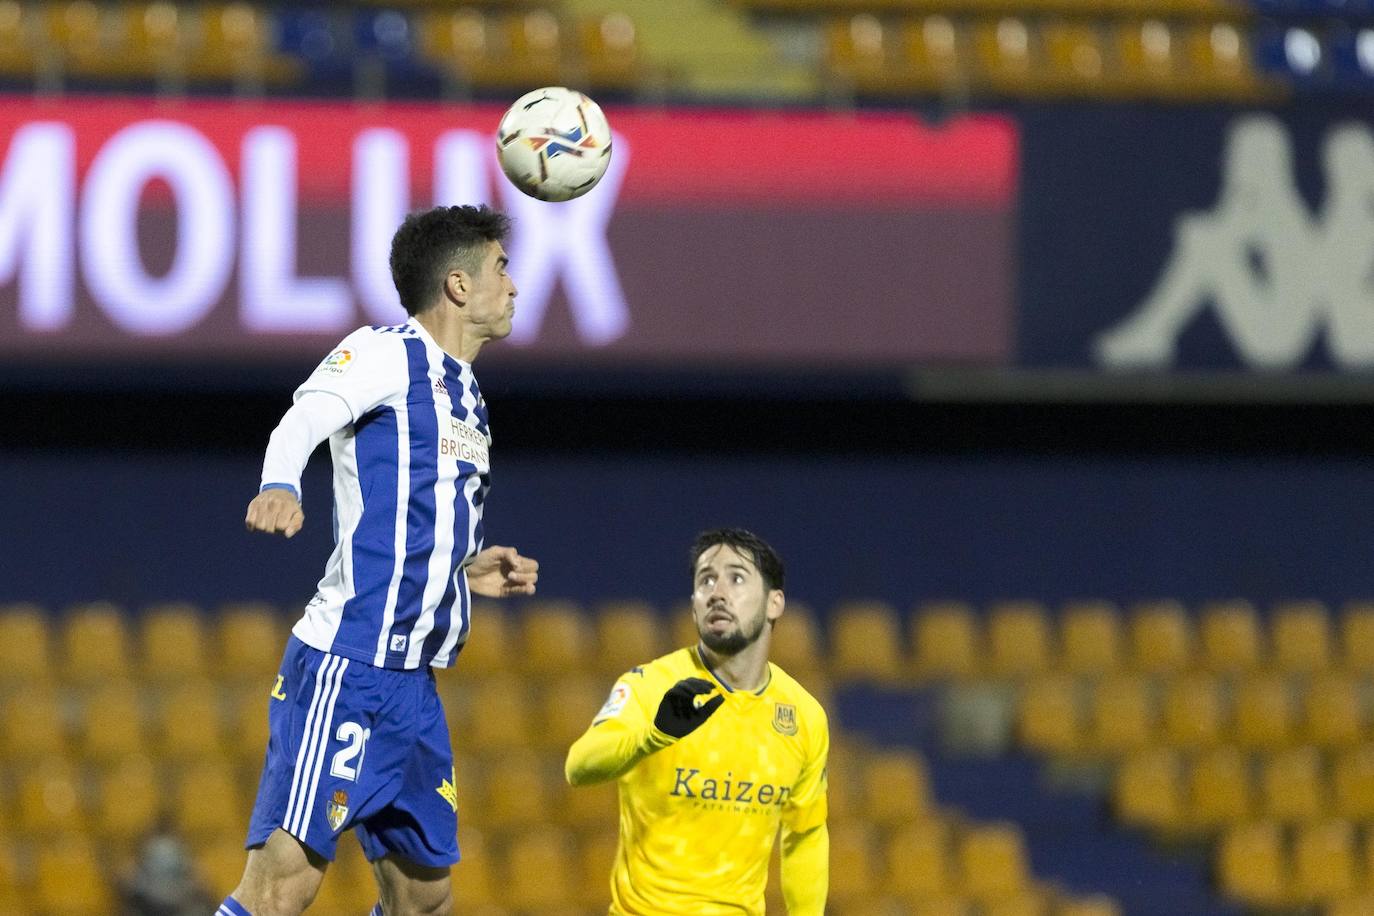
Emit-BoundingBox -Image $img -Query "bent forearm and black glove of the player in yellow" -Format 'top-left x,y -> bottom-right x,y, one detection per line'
563,677 -> 725,786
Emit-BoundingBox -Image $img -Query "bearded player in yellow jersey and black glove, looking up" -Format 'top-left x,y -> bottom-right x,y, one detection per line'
566,529 -> 830,916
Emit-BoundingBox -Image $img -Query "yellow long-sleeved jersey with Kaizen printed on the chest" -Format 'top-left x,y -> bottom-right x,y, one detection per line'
567,648 -> 830,916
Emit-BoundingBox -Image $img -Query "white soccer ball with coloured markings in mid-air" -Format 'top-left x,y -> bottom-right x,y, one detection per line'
496,87 -> 610,201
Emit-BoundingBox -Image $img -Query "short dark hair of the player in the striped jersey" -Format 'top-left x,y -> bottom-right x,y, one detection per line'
390,203 -> 511,314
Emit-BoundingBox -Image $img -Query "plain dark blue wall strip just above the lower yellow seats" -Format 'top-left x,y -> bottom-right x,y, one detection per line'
0,452 -> 1374,608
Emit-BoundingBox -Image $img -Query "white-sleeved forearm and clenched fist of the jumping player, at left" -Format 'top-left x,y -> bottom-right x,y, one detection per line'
243,391 -> 353,537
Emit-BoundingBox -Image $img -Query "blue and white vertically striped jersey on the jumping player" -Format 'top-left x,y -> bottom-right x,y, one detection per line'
293,319 -> 492,669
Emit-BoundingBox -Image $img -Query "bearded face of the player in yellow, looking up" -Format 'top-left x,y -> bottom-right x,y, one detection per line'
691,544 -> 783,655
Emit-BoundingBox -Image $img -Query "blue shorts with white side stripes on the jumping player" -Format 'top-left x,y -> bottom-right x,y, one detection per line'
246,636 -> 459,868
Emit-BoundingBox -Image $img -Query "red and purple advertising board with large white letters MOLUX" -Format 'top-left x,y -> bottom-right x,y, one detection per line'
0,98 -> 1018,365
